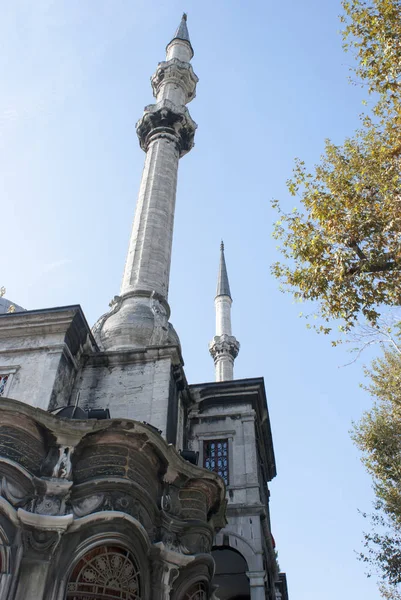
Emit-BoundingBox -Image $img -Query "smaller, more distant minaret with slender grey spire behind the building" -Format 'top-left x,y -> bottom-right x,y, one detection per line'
209,242 -> 239,381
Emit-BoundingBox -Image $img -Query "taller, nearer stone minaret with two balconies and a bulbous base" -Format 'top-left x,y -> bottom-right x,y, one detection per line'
94,14 -> 198,350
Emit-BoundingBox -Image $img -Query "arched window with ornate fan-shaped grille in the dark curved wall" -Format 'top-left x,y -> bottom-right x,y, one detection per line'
66,546 -> 141,600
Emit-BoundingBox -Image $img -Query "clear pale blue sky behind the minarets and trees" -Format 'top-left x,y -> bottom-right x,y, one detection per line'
0,0 -> 379,600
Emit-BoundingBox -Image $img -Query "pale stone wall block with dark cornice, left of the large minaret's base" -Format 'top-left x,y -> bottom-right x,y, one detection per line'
0,306 -> 93,410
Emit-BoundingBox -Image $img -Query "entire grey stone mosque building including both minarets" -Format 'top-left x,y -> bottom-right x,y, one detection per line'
0,15 -> 288,600
